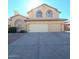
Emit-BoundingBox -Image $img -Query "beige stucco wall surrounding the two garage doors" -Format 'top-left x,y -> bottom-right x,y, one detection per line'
26,21 -> 64,32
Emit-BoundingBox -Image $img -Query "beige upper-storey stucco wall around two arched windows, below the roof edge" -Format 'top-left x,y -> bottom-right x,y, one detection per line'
28,6 -> 59,18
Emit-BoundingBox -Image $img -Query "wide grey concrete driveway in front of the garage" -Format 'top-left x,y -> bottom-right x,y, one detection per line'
9,32 -> 70,59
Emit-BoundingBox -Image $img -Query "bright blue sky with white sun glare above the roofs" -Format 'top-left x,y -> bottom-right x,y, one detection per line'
8,0 -> 70,19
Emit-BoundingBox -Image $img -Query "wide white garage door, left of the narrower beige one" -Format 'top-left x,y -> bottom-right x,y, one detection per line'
29,24 -> 48,32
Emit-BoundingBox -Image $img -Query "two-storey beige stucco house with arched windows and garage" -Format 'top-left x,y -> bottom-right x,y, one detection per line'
10,4 -> 66,32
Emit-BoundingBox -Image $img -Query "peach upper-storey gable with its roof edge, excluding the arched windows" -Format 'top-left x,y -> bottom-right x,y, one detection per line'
28,4 -> 60,18
